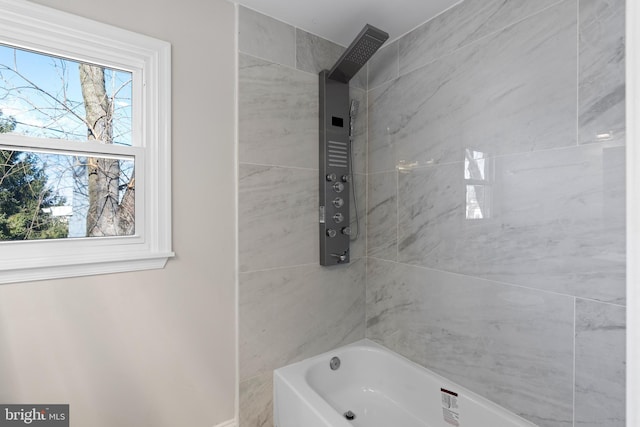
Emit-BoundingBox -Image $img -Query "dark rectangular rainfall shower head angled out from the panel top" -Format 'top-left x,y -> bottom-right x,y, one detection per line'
329,24 -> 389,83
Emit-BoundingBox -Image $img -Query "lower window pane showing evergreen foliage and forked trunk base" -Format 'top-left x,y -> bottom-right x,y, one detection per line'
0,150 -> 135,241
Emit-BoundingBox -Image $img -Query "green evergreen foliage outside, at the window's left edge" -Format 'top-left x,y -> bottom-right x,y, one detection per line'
0,129 -> 69,240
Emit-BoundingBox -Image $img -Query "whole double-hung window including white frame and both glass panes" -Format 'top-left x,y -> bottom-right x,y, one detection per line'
0,0 -> 173,283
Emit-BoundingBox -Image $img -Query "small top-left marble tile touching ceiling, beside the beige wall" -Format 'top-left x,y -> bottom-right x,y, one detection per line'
238,6 -> 296,67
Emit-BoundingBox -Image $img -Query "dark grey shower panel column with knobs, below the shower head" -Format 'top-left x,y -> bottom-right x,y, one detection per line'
319,71 -> 351,265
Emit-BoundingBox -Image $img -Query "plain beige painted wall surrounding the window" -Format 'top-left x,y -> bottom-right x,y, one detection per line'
0,0 -> 236,427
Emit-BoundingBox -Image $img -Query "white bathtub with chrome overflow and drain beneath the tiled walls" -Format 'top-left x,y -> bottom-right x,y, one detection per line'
273,340 -> 535,427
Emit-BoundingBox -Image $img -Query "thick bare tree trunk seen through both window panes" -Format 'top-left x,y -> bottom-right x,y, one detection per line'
80,64 -> 135,237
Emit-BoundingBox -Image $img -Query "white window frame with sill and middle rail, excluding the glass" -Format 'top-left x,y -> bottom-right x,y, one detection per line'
0,0 -> 174,283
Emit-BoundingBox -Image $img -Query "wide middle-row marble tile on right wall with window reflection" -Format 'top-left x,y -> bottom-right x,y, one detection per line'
398,145 -> 625,303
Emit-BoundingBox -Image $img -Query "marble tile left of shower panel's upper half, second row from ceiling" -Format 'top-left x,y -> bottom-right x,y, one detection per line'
238,54 -> 319,169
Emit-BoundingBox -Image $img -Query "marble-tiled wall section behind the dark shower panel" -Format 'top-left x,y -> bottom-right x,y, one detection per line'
238,7 -> 367,427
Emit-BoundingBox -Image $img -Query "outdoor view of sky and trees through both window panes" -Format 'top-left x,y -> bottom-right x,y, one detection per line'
0,45 -> 135,241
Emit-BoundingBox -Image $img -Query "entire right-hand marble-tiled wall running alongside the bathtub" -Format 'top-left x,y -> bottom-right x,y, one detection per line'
366,0 -> 625,427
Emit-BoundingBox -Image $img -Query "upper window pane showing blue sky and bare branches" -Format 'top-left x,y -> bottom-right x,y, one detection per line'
0,45 -> 132,145
